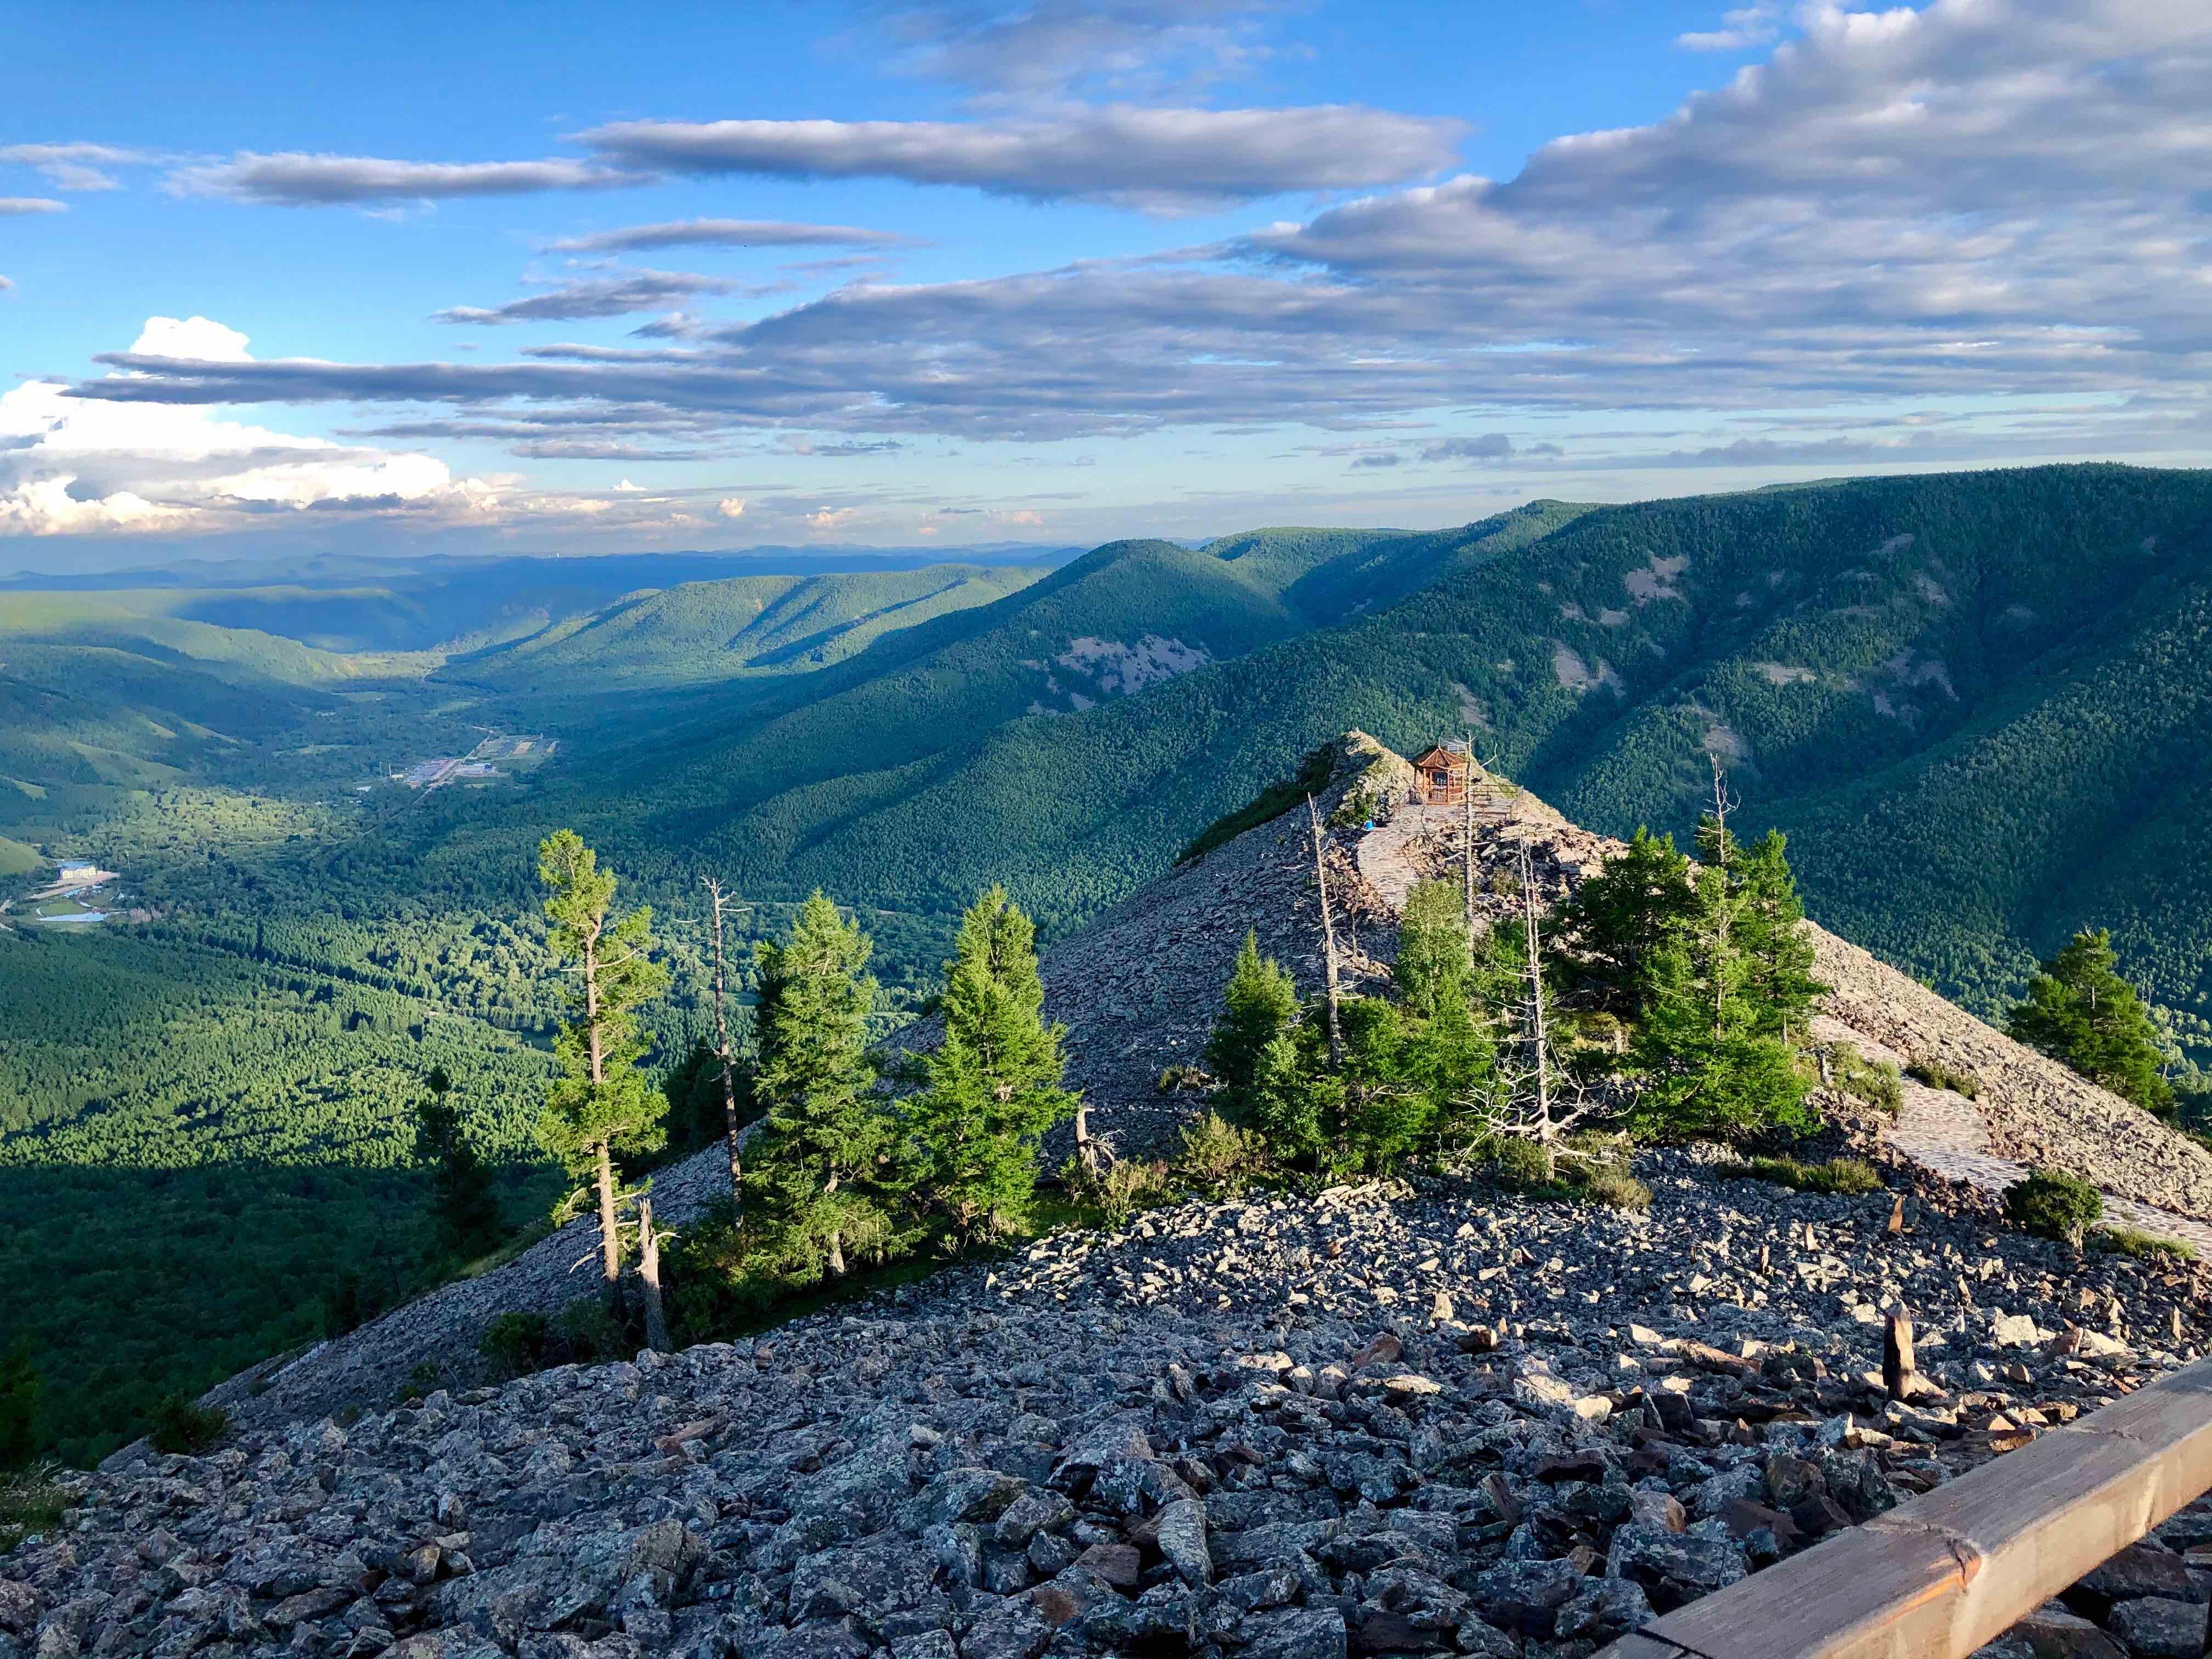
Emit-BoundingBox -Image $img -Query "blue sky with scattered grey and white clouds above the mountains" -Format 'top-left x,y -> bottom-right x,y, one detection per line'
0,0 -> 2212,568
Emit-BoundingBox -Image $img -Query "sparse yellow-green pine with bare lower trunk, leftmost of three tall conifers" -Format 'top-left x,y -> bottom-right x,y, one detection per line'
538,830 -> 668,1296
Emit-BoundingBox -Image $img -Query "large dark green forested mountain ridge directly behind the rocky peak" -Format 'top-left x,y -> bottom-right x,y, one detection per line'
584,467 -> 2212,1026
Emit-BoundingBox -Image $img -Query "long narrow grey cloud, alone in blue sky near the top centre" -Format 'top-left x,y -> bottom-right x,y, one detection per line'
582,104 -> 1464,212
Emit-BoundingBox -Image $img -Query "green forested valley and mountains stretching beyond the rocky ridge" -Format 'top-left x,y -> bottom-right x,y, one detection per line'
0,467 -> 2212,1460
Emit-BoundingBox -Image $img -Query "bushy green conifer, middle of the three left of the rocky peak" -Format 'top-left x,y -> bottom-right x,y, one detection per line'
746,891 -> 898,1278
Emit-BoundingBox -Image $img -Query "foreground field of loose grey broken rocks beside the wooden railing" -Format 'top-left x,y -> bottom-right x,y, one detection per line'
13,1150 -> 2212,1659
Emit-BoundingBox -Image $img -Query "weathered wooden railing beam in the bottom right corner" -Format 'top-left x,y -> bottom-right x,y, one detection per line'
1597,1361 -> 2212,1659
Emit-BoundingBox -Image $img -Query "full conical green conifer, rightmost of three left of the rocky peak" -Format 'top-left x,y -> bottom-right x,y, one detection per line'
909,887 -> 1075,1245
